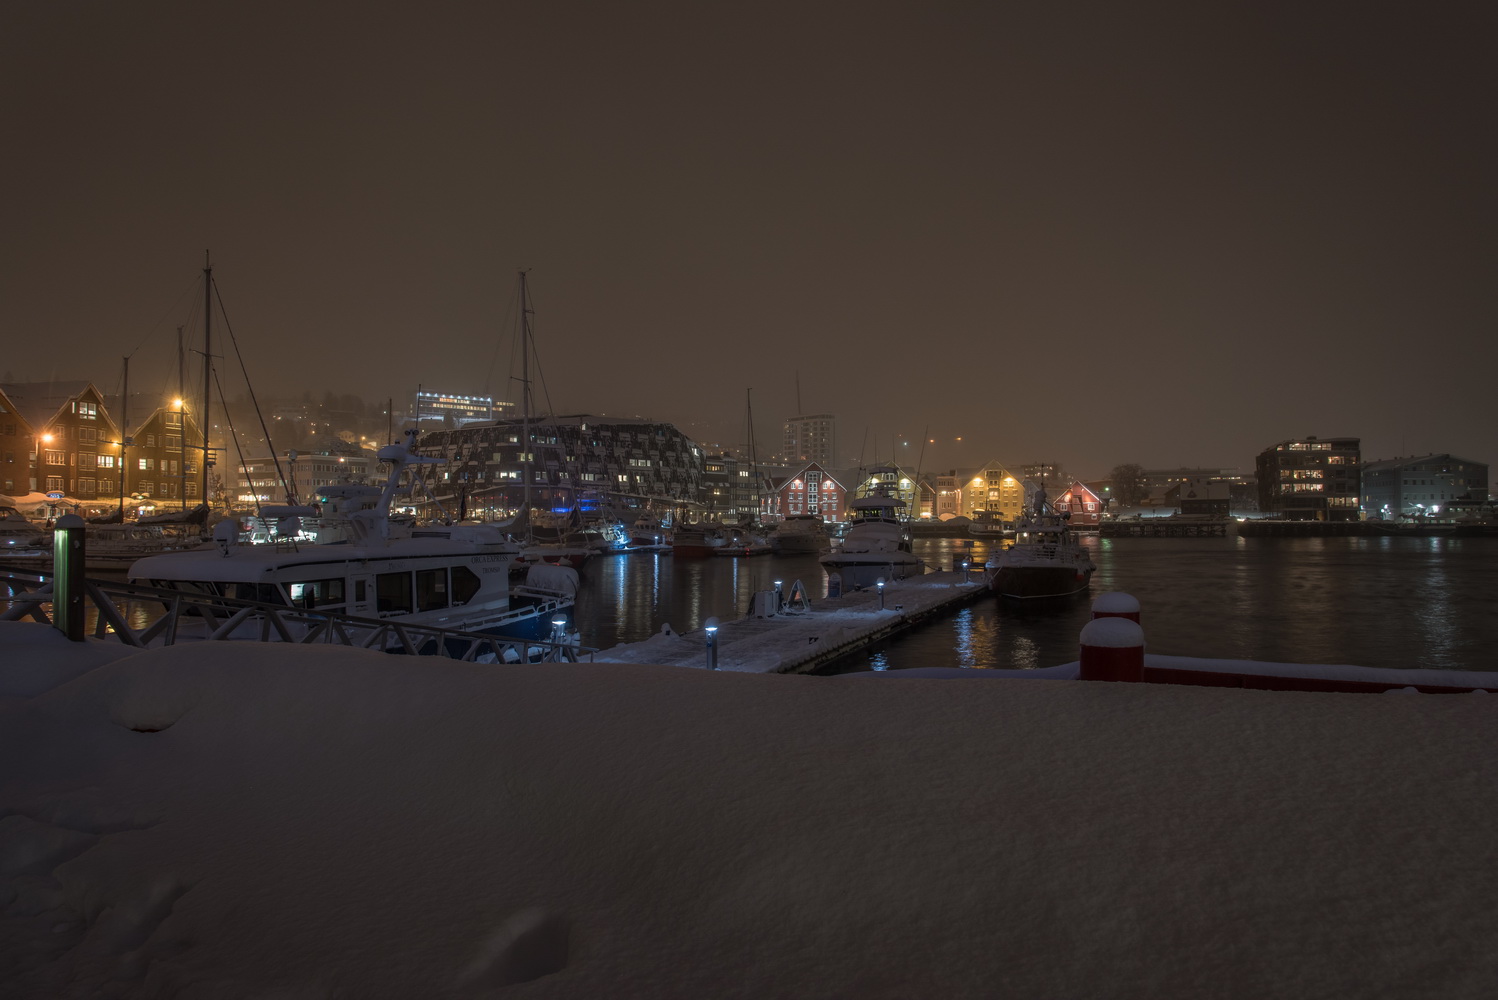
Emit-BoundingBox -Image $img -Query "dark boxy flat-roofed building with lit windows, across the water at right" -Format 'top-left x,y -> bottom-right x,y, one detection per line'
1255,437 -> 1362,521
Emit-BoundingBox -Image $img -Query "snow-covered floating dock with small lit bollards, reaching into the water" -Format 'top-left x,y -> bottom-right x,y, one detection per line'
593,572 -> 989,674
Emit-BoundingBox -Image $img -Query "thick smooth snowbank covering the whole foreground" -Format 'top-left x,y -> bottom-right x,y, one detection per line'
0,624 -> 1498,1000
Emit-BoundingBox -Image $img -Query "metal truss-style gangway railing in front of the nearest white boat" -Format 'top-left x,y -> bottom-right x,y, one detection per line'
0,570 -> 598,663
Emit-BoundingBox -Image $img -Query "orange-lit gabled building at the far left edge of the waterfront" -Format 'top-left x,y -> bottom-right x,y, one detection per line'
0,382 -> 120,504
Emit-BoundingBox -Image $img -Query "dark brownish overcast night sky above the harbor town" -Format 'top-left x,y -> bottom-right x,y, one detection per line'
0,0 -> 1498,476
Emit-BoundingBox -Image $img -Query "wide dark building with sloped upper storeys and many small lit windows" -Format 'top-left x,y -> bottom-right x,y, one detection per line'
415,415 -> 706,513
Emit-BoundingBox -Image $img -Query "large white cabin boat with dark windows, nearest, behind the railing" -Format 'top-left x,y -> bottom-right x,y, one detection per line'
130,431 -> 577,639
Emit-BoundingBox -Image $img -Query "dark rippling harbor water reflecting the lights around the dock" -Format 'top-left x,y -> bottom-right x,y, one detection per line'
575,536 -> 1498,671
